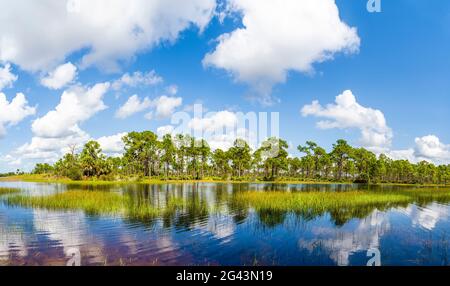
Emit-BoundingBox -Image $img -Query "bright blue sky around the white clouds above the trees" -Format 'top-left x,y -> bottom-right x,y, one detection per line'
0,0 -> 450,172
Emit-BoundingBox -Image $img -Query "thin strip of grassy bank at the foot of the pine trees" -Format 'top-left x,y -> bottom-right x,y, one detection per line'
0,175 -> 450,187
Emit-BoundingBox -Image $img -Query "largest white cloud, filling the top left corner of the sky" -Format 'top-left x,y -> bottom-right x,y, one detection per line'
0,0 -> 216,71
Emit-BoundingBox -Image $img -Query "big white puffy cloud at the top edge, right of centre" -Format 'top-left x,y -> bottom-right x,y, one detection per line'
203,0 -> 360,103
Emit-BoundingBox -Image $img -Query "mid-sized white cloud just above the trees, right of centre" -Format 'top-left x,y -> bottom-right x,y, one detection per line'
301,90 -> 393,149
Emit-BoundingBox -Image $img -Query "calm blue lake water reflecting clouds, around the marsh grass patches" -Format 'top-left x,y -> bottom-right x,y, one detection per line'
0,182 -> 450,266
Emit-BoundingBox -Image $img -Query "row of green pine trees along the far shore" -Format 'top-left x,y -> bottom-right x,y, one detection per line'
33,131 -> 450,184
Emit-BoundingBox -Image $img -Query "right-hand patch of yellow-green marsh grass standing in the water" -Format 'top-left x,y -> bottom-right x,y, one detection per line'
233,189 -> 450,225
